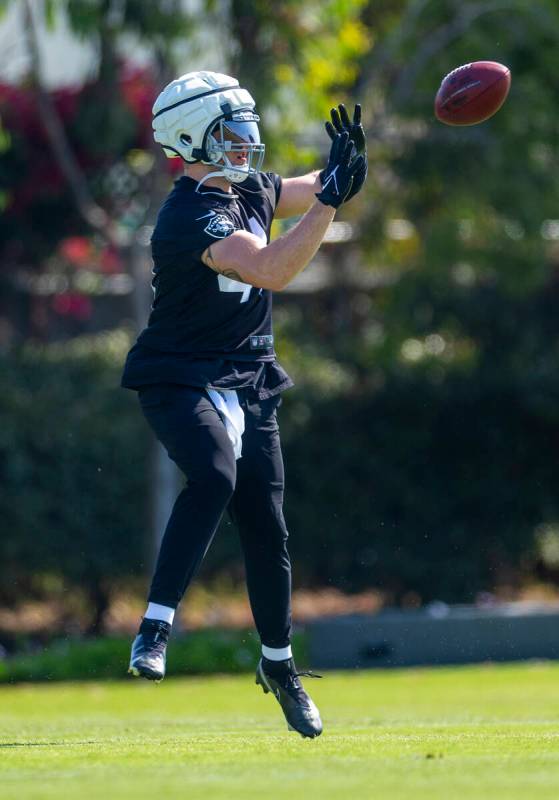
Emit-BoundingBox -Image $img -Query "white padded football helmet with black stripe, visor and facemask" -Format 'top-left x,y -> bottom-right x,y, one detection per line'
153,72 -> 265,183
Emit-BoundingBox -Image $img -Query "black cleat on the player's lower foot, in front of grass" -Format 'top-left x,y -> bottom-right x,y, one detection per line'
256,658 -> 322,739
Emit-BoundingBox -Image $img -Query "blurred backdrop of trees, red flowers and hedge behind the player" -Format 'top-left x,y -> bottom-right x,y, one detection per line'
0,0 -> 559,649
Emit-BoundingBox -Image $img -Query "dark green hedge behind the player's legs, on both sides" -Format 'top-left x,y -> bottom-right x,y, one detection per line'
0,312 -> 559,630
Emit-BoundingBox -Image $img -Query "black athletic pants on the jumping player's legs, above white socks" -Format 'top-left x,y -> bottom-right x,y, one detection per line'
139,384 -> 291,647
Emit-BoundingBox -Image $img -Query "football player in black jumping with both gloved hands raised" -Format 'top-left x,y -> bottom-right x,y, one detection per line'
122,72 -> 367,738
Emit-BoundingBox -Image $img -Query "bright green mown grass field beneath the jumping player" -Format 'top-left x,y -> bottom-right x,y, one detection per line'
0,664 -> 559,800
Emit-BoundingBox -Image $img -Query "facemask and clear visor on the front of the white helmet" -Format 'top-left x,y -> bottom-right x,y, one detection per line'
204,110 -> 265,183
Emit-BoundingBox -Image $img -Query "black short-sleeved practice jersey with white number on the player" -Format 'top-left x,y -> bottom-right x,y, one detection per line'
123,173 -> 292,396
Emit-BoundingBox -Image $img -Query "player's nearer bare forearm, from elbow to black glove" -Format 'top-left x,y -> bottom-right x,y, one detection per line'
255,201 -> 336,291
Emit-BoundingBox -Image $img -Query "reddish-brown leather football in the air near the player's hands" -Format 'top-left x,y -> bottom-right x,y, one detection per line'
435,61 -> 510,125
